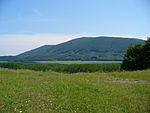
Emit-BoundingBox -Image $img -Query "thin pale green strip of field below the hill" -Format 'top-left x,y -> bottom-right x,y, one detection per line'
35,61 -> 122,64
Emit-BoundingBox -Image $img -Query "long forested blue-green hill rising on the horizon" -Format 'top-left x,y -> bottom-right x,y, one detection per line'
0,36 -> 144,61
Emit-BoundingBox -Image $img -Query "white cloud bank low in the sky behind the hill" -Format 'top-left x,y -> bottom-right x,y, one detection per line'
0,33 -> 146,56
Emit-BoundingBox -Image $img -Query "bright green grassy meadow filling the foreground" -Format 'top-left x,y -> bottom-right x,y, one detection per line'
0,69 -> 150,113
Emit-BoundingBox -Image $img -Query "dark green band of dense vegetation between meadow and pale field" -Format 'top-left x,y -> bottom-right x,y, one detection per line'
0,62 -> 120,73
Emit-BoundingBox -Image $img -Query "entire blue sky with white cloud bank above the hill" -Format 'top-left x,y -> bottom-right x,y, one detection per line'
0,0 -> 150,56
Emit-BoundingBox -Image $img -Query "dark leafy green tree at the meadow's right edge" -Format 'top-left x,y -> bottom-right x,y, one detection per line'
121,39 -> 150,70
